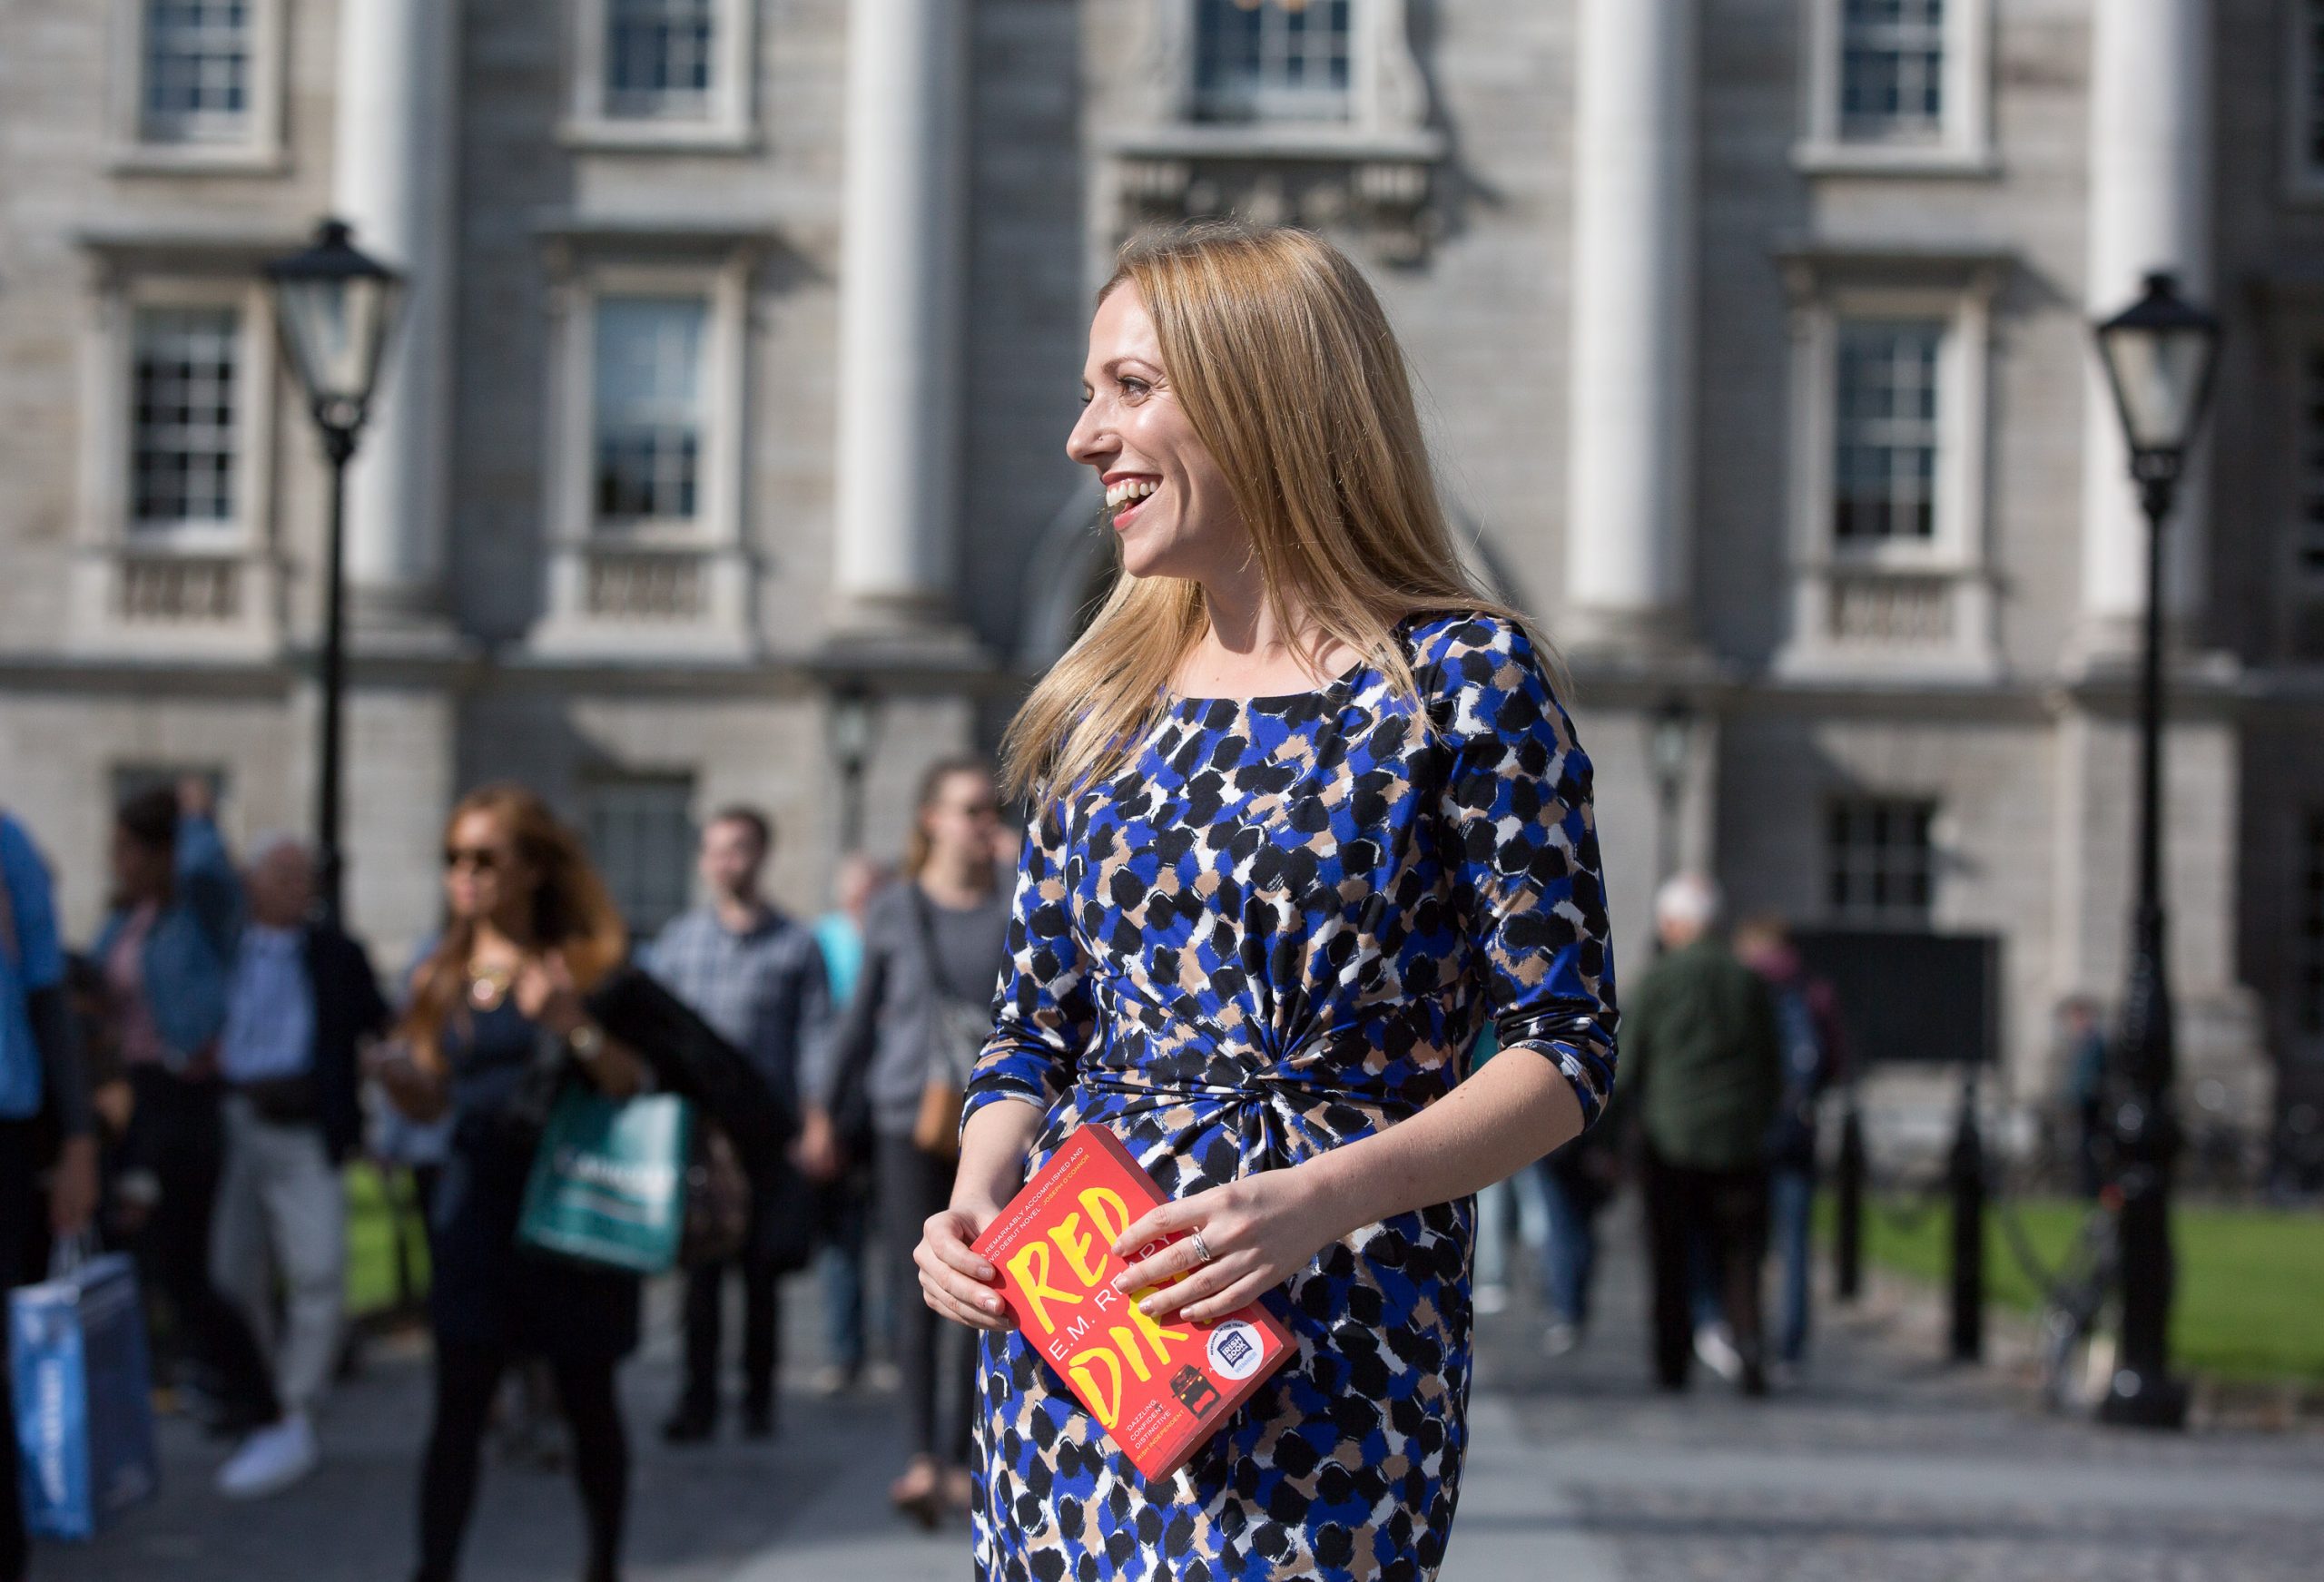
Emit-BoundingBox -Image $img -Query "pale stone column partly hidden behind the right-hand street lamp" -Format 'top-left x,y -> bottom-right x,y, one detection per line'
2083,0 -> 2212,651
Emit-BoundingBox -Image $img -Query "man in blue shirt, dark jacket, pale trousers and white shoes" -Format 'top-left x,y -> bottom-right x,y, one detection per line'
209,836 -> 389,1498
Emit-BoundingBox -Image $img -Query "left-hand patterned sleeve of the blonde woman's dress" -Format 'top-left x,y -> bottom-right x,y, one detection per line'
962,809 -> 1097,1120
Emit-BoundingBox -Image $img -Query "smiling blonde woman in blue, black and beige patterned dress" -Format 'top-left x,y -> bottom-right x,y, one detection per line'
916,228 -> 1615,1582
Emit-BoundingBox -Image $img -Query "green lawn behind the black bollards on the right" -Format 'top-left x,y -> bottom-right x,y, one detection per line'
1817,1194 -> 2324,1382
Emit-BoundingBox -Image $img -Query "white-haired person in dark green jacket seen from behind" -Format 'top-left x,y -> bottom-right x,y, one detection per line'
1615,873 -> 1783,1396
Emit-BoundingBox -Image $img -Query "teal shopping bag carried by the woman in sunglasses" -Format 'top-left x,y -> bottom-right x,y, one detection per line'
516,1085 -> 693,1275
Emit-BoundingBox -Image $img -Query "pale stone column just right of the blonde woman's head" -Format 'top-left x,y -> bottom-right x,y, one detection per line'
1564,0 -> 1697,651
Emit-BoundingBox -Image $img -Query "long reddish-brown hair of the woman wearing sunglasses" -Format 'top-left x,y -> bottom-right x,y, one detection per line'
398,783 -> 630,1071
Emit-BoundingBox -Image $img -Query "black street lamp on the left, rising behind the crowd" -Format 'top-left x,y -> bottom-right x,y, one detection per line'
265,221 -> 404,922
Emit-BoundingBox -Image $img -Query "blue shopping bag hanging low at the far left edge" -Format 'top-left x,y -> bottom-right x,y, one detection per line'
7,1253 -> 161,1538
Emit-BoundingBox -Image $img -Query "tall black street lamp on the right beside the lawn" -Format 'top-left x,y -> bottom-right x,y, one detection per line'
2096,274 -> 2220,1429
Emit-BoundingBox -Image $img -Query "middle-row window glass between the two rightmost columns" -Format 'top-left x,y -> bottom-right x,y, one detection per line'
1831,319 -> 1945,544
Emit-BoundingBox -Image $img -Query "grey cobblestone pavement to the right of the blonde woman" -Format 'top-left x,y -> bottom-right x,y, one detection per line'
1448,1215 -> 2324,1582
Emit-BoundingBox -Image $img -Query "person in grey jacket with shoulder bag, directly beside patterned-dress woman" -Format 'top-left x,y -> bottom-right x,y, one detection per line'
802,757 -> 1009,1527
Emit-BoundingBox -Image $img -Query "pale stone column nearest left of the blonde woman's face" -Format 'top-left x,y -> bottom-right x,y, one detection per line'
834,0 -> 970,630
